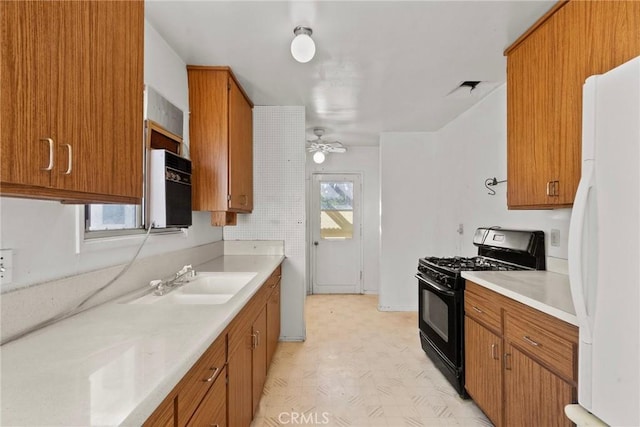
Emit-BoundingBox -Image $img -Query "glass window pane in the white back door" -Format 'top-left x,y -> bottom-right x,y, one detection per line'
320,181 -> 353,240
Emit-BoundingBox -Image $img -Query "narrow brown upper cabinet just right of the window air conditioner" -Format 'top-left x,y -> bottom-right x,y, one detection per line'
187,65 -> 253,225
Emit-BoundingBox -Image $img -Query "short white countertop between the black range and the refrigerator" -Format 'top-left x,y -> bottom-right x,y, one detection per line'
462,271 -> 578,326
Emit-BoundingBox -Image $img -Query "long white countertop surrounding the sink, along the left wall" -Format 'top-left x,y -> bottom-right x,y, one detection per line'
0,255 -> 284,426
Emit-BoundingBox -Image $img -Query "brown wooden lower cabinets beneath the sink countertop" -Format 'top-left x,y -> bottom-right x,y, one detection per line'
144,266 -> 281,427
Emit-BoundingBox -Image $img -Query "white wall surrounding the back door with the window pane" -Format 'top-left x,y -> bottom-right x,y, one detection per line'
307,146 -> 380,294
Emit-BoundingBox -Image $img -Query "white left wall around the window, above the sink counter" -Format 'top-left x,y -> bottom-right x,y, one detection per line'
0,21 -> 222,292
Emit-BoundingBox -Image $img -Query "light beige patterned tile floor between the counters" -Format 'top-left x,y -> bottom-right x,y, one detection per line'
252,295 -> 491,427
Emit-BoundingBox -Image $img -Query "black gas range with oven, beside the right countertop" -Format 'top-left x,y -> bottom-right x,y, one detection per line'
416,227 -> 546,397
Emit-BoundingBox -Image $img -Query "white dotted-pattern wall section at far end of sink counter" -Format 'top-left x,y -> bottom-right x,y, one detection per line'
224,106 -> 307,341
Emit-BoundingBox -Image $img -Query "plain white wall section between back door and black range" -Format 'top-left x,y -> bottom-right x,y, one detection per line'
378,132 -> 442,311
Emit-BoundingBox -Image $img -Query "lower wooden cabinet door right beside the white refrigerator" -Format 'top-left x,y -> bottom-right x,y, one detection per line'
504,344 -> 575,427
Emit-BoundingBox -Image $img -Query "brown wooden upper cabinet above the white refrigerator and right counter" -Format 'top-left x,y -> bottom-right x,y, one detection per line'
505,1 -> 640,209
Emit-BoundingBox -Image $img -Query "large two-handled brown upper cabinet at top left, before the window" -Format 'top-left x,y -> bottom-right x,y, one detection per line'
0,1 -> 144,204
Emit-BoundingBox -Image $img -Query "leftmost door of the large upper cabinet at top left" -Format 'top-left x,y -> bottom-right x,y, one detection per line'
0,1 -> 60,187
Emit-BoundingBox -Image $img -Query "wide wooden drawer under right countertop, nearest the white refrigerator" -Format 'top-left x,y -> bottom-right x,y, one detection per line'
505,312 -> 576,380
